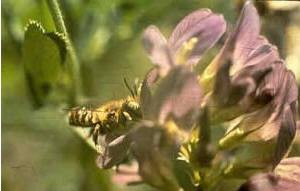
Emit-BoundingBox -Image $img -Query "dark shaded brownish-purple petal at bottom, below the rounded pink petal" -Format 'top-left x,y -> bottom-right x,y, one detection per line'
130,121 -> 179,191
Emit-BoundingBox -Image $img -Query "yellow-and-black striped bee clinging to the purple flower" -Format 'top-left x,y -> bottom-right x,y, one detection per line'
68,79 -> 142,145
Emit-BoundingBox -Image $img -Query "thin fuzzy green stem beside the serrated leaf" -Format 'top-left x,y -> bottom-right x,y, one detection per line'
47,0 -> 81,105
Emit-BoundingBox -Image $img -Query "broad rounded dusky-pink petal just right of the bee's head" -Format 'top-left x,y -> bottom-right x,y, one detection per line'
151,66 -> 202,128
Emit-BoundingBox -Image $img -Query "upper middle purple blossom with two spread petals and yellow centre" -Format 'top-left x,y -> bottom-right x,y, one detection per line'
143,9 -> 226,75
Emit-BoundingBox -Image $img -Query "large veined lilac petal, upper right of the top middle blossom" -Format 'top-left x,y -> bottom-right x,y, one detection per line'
168,9 -> 226,64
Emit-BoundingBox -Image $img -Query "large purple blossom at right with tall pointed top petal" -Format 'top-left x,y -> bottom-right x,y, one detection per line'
204,2 -> 298,169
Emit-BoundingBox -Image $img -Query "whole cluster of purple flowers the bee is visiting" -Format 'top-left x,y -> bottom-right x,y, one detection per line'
85,2 -> 300,191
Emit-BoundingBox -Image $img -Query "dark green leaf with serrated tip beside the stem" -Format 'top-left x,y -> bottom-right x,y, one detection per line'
23,21 -> 67,107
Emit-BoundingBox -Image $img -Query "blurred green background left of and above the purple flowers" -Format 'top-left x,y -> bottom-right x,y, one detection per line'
1,0 -> 298,191
